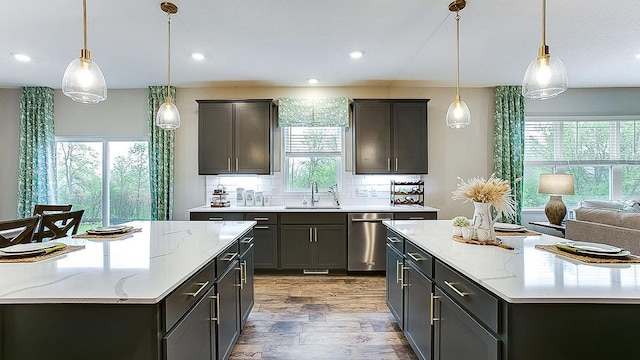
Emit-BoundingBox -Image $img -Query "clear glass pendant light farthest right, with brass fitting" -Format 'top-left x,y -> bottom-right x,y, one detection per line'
522,0 -> 568,100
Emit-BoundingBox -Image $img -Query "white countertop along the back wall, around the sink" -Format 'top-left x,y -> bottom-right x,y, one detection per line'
189,205 -> 440,213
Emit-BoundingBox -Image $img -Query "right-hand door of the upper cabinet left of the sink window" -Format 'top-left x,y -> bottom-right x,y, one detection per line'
233,101 -> 271,175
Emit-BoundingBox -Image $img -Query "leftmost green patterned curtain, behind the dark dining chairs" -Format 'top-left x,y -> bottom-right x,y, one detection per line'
17,87 -> 56,217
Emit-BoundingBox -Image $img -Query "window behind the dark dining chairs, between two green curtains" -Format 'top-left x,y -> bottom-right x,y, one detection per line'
56,138 -> 151,228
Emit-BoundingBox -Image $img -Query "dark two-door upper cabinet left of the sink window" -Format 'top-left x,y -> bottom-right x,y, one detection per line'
197,99 -> 273,175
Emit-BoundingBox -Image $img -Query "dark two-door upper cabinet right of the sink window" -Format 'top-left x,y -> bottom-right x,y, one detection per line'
353,99 -> 429,174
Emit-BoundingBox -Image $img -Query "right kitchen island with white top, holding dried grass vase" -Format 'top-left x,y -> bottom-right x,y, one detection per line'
384,220 -> 640,360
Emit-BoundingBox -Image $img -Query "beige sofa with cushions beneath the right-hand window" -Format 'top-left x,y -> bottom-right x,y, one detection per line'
565,200 -> 640,255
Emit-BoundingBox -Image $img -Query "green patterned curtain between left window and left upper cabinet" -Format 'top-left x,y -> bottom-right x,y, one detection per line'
147,86 -> 176,220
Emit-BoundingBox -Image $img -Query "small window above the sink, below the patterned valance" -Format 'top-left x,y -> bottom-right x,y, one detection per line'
282,127 -> 343,191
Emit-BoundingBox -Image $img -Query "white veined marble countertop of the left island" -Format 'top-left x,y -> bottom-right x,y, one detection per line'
0,221 -> 255,304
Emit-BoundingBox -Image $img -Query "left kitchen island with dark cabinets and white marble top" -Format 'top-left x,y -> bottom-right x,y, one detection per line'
0,221 -> 255,360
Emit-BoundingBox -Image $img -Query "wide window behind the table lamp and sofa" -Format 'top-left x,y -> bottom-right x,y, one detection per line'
523,116 -> 640,207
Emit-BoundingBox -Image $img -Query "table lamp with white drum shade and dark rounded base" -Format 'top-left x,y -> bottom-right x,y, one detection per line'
538,174 -> 575,225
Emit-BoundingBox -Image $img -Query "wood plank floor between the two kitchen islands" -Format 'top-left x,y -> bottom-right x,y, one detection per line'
230,274 -> 417,360
